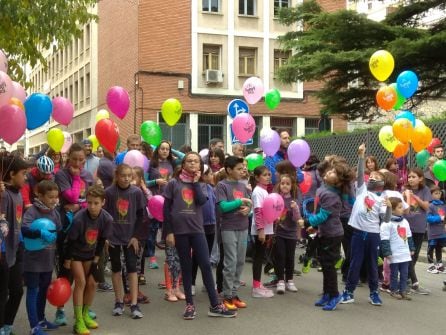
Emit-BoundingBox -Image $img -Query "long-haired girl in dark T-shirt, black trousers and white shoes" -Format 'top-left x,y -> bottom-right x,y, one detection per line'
274,175 -> 304,294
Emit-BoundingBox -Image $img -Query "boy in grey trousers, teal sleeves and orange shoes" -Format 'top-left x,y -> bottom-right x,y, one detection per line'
215,156 -> 252,310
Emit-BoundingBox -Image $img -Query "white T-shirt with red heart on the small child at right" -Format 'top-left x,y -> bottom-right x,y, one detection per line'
380,219 -> 412,263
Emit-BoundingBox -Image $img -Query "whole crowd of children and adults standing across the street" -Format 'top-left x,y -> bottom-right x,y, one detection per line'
0,129 -> 446,335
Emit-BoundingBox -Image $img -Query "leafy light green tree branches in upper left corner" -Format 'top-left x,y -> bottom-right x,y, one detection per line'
0,0 -> 97,82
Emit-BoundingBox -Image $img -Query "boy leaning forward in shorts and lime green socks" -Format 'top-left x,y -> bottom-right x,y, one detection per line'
67,185 -> 113,335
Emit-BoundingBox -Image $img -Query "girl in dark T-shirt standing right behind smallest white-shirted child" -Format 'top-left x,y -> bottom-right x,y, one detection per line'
403,168 -> 432,295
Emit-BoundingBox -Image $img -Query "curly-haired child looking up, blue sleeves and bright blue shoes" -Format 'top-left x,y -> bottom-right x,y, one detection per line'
308,162 -> 354,311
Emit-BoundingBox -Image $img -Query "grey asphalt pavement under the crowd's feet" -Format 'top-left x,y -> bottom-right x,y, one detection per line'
15,252 -> 446,335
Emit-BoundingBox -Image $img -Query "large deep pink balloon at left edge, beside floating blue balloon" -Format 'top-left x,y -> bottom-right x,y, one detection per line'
0,105 -> 26,144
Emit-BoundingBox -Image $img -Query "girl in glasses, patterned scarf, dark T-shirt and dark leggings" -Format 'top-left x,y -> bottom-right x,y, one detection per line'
163,152 -> 236,320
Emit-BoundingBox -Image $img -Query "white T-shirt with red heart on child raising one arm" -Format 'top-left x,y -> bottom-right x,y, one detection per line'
348,183 -> 387,234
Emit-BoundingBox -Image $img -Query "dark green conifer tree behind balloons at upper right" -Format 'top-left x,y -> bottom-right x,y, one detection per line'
279,0 -> 446,121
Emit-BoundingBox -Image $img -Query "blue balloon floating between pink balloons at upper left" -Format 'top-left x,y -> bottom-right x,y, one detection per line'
24,93 -> 53,130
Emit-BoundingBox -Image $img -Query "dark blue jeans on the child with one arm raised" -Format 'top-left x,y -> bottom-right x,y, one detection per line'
345,229 -> 381,292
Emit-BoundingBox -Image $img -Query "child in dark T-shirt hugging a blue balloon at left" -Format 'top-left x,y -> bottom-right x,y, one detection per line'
22,180 -> 61,335
